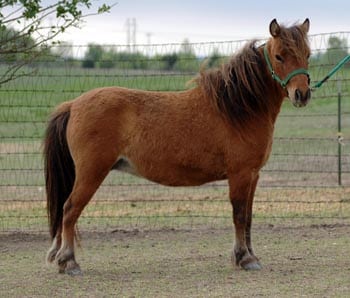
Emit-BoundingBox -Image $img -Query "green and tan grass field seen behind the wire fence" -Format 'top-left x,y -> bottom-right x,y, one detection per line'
0,56 -> 350,230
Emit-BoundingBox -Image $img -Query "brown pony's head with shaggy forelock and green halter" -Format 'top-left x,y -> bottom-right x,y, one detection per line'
264,19 -> 311,107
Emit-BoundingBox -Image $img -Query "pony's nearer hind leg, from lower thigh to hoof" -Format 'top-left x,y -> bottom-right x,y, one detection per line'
56,160 -> 110,275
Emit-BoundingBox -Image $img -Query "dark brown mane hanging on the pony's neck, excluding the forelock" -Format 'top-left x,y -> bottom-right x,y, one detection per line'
195,41 -> 268,125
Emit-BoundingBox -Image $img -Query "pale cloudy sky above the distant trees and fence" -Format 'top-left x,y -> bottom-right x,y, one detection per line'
56,0 -> 350,45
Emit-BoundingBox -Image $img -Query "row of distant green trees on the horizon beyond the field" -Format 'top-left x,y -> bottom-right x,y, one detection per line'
0,30 -> 350,72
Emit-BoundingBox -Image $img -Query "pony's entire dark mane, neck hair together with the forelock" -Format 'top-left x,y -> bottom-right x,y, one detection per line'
194,25 -> 310,126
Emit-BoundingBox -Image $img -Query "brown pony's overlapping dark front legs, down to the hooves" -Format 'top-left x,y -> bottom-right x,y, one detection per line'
229,173 -> 261,270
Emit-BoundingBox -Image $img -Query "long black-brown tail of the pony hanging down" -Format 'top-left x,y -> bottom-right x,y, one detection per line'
44,103 -> 75,238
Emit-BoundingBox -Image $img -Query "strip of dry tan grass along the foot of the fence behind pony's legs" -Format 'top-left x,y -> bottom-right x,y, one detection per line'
0,185 -> 350,232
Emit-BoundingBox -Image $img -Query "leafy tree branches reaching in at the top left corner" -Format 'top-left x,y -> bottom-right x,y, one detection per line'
0,0 -> 113,86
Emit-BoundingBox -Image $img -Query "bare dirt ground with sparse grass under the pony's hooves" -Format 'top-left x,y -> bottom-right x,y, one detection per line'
0,224 -> 350,297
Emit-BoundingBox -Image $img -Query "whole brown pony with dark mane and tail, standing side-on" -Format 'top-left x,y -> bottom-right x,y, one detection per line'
44,19 -> 310,275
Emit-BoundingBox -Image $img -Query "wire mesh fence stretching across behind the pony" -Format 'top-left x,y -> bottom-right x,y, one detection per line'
0,32 -> 350,232
